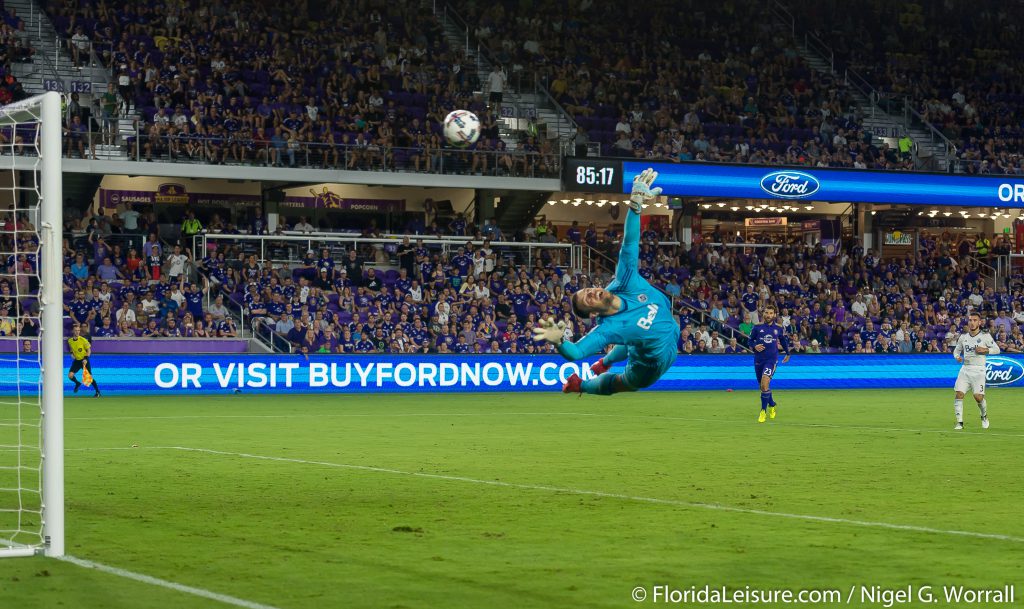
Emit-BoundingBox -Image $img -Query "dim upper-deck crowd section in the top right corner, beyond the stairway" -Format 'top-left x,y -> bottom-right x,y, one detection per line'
753,0 -> 1024,175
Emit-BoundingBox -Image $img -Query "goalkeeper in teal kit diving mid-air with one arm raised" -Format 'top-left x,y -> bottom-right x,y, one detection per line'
534,169 -> 679,395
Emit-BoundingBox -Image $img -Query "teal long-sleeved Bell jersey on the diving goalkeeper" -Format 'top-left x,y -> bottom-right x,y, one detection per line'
559,210 -> 679,366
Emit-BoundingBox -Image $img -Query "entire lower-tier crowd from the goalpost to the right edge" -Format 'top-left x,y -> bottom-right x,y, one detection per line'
44,204 -> 1024,353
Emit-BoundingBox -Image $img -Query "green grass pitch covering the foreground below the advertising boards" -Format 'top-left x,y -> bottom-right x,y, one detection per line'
0,389 -> 1024,609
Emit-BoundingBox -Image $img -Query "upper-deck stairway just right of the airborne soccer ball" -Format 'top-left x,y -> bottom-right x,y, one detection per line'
431,4 -> 575,150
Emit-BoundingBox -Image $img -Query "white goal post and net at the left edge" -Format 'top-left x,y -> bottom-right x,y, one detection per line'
0,93 -> 63,557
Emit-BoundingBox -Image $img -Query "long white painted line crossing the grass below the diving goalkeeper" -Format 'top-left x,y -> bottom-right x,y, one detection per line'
130,446 -> 1024,543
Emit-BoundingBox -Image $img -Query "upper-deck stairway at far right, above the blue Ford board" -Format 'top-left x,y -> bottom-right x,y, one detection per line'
798,45 -> 948,171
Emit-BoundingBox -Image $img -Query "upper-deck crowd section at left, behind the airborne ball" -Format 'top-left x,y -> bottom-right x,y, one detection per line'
47,0 -> 558,175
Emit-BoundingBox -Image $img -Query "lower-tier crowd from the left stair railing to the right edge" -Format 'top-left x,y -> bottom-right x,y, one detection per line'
230,224 -> 1024,353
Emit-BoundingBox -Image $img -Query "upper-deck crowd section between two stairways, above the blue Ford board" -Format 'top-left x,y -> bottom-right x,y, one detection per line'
460,0 -> 913,170
